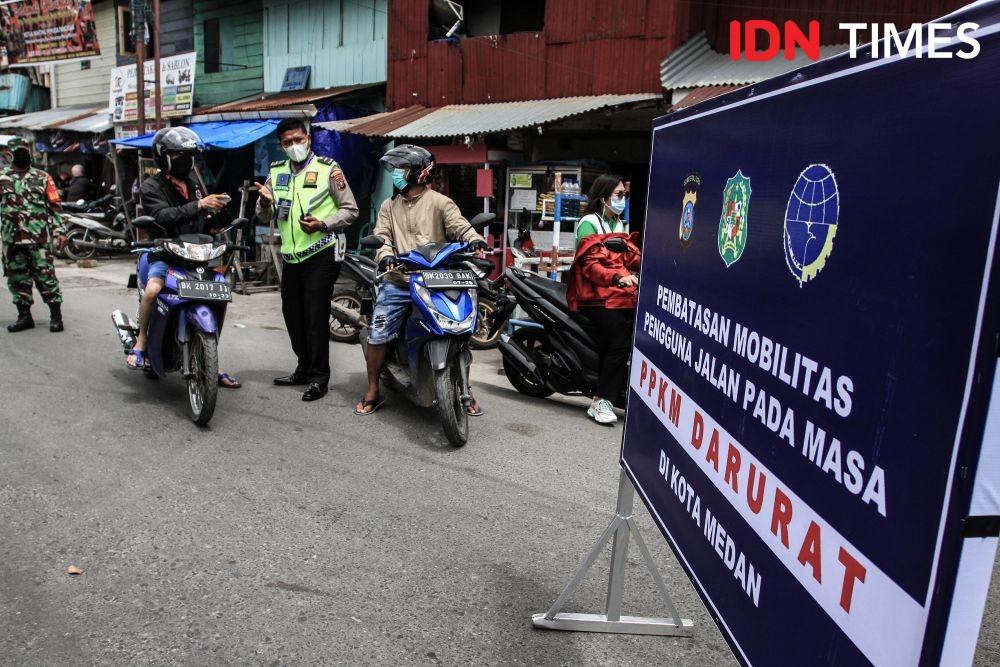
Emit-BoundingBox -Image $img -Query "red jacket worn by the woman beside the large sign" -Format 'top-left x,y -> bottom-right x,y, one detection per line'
566,232 -> 642,310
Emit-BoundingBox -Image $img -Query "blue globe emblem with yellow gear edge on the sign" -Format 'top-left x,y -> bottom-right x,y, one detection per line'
784,164 -> 840,287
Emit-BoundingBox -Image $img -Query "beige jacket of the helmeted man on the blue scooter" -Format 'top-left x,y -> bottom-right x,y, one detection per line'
373,190 -> 484,277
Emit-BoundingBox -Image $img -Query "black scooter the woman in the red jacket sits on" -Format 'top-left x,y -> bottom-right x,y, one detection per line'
499,238 -> 628,408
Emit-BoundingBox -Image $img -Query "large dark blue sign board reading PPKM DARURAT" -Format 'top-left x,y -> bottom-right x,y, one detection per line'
622,9 -> 1000,665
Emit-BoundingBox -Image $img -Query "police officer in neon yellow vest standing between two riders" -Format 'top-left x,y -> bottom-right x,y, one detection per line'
257,118 -> 358,401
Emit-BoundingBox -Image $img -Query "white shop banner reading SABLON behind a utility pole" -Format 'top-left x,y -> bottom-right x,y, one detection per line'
108,52 -> 195,124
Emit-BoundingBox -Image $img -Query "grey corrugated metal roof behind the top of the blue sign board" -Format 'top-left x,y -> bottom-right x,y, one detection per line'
660,32 -> 849,90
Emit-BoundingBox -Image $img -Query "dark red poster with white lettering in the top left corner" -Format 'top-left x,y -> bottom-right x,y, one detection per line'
0,0 -> 101,67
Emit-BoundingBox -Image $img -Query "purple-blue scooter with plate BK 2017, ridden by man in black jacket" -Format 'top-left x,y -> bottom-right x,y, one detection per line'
111,216 -> 246,426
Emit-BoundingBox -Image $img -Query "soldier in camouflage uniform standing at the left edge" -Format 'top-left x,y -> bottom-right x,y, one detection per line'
0,137 -> 66,331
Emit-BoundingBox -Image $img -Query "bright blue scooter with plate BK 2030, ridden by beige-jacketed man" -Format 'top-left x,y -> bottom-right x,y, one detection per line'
360,213 -> 495,447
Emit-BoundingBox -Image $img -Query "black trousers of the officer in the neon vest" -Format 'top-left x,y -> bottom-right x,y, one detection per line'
281,247 -> 340,385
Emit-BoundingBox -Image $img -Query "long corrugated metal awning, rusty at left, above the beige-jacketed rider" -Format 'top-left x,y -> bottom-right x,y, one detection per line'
316,93 -> 663,139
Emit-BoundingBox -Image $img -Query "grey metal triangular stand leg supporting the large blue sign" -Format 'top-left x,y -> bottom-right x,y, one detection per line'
531,470 -> 694,637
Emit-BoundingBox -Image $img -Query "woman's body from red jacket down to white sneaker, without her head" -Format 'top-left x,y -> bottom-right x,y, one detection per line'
567,233 -> 641,425
